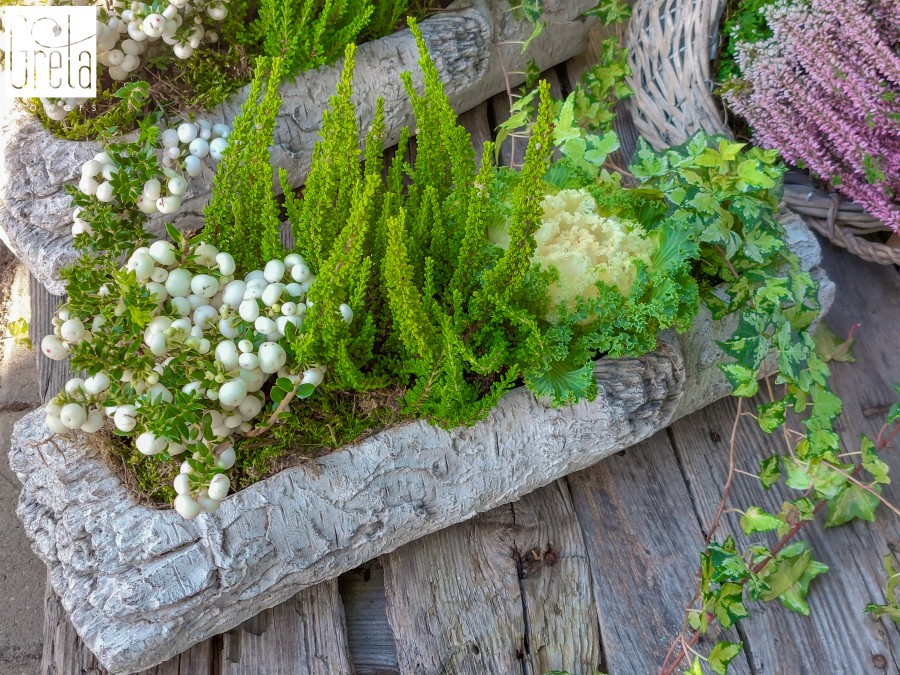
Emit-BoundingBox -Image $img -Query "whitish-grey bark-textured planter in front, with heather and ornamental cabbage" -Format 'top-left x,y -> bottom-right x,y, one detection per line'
10,216 -> 834,673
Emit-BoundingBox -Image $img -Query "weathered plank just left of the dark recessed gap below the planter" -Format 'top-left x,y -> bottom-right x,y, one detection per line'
216,580 -> 351,675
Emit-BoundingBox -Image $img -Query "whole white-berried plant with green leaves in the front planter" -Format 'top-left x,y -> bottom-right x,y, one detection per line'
41,113 -> 338,518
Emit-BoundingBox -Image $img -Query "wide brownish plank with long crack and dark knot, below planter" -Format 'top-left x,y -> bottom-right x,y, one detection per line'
382,481 -> 601,675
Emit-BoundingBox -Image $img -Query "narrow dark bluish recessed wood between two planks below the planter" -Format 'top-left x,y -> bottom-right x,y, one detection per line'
338,560 -> 399,675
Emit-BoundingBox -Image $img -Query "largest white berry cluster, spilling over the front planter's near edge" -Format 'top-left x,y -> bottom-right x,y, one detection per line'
41,241 -> 353,518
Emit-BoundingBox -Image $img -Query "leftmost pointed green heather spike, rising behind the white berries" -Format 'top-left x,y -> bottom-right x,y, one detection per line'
204,58 -> 284,270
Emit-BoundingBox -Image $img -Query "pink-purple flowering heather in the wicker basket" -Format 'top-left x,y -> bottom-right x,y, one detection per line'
724,0 -> 900,233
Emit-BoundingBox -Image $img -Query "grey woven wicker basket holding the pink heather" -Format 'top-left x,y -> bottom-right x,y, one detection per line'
627,0 -> 900,265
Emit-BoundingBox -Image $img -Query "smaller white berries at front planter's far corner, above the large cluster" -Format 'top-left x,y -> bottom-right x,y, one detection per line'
72,119 -> 231,230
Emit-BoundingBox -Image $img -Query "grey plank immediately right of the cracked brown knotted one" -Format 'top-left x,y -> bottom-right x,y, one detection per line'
567,431 -> 750,675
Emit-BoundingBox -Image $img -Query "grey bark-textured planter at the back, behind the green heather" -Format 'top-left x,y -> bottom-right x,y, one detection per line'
0,0 -> 596,295
